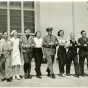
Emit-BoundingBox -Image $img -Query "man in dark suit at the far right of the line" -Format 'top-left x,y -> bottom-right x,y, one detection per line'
78,30 -> 88,76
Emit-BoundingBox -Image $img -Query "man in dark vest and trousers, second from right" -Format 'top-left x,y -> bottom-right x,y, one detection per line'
66,33 -> 79,77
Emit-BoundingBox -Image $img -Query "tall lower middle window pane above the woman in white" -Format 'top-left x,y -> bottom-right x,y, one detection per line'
10,10 -> 21,33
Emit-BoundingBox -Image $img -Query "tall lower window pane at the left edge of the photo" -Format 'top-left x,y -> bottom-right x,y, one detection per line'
0,9 -> 7,33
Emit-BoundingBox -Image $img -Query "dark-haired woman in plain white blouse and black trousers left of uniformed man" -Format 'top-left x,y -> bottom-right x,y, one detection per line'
34,31 -> 43,78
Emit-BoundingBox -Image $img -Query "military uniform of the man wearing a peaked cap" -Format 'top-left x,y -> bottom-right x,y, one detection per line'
43,35 -> 58,74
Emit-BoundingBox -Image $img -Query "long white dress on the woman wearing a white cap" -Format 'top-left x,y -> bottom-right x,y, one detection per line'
11,38 -> 22,66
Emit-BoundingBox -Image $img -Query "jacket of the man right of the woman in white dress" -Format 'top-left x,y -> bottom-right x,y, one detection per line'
21,34 -> 35,52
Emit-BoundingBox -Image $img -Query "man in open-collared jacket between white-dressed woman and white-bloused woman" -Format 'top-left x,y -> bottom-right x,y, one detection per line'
21,29 -> 35,79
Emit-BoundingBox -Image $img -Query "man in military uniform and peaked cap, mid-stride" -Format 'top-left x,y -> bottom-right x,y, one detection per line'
43,27 -> 58,78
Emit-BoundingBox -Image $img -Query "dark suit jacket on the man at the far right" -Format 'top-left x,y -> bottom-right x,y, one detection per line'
78,37 -> 88,56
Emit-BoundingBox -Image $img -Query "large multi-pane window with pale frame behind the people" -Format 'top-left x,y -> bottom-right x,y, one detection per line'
0,1 -> 35,33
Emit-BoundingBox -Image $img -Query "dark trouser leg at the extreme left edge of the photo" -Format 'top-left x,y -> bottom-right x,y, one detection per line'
0,54 -> 5,77
